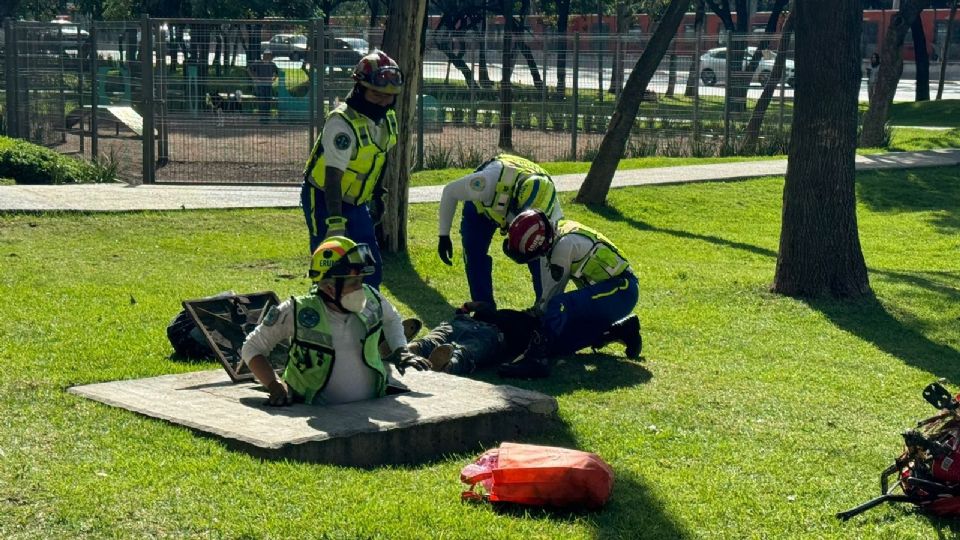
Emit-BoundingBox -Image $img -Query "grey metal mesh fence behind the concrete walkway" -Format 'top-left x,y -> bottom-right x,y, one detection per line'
0,19 -> 793,183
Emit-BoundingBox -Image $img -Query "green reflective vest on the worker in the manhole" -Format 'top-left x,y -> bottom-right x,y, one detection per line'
283,285 -> 387,404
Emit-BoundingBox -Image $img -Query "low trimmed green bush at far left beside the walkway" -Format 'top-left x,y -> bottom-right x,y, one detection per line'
0,137 -> 116,184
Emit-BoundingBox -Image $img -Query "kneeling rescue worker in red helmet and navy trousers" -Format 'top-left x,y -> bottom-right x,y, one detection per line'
498,210 -> 643,377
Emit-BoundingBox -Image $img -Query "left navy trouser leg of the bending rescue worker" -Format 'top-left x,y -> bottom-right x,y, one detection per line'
460,202 -> 497,303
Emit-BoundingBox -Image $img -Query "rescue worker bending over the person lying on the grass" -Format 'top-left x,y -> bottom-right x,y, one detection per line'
437,154 -> 563,304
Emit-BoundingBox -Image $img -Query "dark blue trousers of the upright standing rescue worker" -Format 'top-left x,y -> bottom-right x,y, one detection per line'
300,182 -> 383,289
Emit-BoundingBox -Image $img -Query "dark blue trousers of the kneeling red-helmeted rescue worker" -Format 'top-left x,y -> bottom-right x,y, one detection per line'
541,272 -> 640,356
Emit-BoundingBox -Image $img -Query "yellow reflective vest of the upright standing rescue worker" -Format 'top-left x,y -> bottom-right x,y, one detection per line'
304,103 -> 397,204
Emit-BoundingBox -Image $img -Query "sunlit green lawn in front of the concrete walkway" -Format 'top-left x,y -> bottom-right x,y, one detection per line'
0,168 -> 960,539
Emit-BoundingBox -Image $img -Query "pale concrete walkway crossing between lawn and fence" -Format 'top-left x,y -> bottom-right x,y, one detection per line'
0,148 -> 960,212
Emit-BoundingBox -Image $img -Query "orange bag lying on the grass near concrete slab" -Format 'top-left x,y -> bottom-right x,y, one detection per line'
460,443 -> 613,510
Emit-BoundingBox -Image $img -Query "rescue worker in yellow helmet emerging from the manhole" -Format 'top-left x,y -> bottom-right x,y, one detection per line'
240,236 -> 430,405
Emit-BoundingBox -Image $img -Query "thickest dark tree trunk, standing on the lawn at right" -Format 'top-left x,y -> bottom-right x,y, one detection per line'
773,0 -> 870,298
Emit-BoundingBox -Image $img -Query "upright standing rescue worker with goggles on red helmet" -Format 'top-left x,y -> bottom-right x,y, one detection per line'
300,51 -> 403,287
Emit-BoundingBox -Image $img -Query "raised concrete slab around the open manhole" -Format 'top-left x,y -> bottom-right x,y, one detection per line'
68,370 -> 557,467
